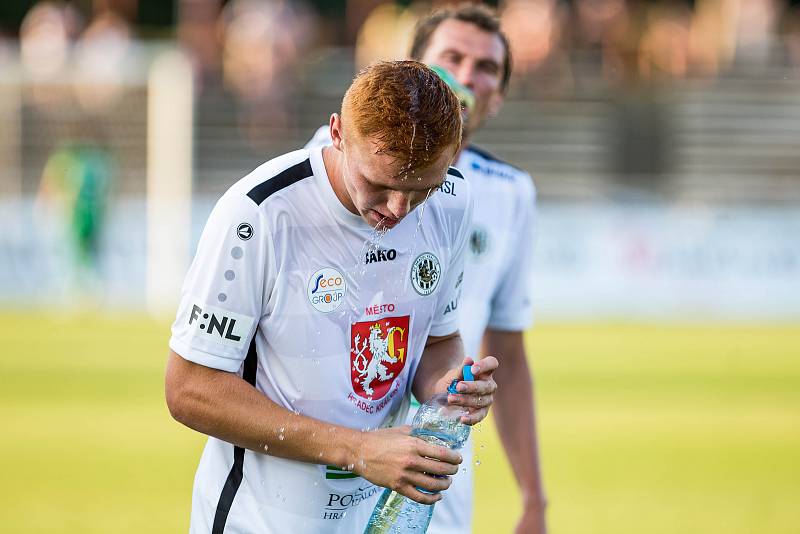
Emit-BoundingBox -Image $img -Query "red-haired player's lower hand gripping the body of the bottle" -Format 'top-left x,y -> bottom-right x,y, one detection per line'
353,426 -> 461,504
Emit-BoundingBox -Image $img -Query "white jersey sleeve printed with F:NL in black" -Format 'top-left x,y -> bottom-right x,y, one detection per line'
169,191 -> 275,372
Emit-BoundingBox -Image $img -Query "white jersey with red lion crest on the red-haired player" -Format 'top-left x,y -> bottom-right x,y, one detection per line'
170,148 -> 471,534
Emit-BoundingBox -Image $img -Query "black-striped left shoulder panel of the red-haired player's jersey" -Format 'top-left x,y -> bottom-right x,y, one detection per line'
226,149 -> 314,211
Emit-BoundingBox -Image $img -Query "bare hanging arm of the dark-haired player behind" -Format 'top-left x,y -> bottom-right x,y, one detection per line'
481,328 -> 547,534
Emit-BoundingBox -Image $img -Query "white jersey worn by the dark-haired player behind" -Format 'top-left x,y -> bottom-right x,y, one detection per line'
306,126 -> 536,534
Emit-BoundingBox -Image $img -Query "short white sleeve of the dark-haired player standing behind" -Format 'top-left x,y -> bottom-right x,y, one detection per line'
487,175 -> 536,331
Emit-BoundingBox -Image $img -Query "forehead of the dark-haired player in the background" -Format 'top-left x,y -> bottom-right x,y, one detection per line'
422,19 -> 505,65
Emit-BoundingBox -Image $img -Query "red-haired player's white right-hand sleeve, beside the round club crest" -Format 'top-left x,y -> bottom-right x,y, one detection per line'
430,181 -> 473,336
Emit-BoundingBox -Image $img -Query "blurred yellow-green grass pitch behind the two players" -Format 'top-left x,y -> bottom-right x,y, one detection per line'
0,312 -> 800,534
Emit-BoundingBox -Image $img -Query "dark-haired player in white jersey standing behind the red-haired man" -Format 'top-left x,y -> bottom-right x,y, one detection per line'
309,4 -> 547,534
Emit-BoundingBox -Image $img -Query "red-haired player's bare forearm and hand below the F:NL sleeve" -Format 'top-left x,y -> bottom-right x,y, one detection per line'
166,351 -> 461,504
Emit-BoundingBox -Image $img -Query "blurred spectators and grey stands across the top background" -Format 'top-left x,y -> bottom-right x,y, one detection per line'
0,0 -> 800,201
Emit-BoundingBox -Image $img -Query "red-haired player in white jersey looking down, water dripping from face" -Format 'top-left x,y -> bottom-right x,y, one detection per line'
166,61 -> 497,534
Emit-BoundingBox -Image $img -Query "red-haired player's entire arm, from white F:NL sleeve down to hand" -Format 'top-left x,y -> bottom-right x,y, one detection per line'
165,182 -> 461,503
